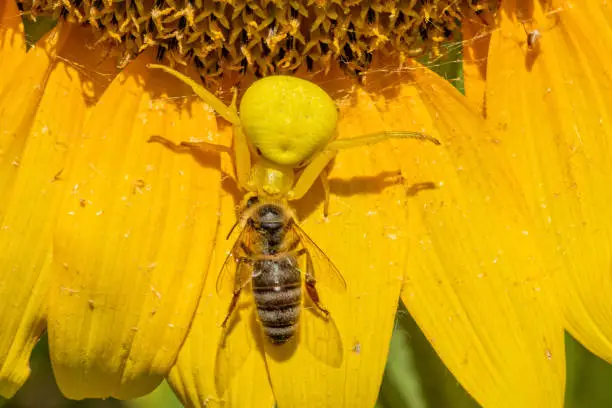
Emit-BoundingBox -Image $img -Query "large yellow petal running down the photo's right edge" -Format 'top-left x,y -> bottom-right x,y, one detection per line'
487,1 -> 612,361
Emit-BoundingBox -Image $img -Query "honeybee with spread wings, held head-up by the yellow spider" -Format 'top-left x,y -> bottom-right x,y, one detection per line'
217,195 -> 346,345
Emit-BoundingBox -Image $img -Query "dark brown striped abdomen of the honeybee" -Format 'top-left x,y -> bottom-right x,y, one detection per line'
253,255 -> 302,344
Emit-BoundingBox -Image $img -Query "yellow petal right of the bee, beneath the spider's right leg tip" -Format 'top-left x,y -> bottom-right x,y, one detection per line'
402,62 -> 565,407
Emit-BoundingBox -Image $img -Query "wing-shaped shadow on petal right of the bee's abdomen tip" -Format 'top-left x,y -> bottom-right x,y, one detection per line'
300,296 -> 343,368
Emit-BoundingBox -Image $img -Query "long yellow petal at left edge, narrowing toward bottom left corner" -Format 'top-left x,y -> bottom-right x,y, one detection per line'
0,21 -> 105,397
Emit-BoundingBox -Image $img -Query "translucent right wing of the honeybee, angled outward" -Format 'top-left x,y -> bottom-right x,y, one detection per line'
292,221 -> 346,293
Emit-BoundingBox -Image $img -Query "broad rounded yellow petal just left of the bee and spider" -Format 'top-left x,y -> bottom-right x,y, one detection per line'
48,55 -> 220,399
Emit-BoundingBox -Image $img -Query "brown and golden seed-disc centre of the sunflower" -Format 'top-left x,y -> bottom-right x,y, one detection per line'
17,0 -> 498,77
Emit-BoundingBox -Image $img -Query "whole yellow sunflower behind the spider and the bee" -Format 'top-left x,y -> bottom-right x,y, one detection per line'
0,0 -> 612,407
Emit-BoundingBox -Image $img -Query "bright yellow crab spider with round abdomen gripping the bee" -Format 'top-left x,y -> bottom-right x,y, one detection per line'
149,64 -> 440,214
